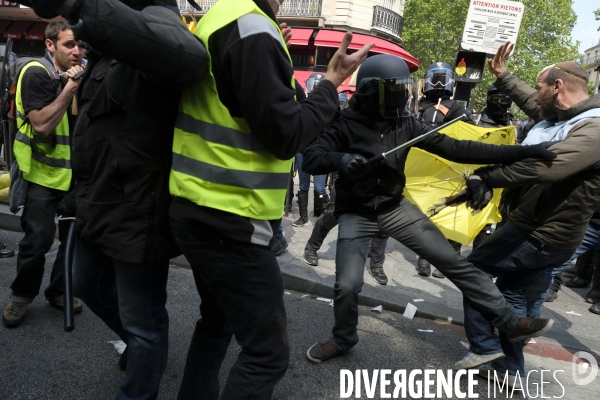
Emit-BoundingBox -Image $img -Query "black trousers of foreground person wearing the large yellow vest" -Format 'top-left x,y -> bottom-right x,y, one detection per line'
172,220 -> 290,400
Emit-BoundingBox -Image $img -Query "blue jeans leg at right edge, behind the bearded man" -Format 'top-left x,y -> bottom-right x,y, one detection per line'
527,222 -> 600,318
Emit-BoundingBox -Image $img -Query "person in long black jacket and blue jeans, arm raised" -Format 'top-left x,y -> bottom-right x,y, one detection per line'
17,0 -> 207,399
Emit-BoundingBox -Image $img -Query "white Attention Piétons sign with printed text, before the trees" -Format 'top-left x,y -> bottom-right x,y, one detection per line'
461,0 -> 525,56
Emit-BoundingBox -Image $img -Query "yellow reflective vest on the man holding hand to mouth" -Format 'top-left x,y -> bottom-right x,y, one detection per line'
14,61 -> 72,191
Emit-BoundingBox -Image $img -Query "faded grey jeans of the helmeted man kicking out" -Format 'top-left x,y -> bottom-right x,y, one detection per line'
332,199 -> 518,352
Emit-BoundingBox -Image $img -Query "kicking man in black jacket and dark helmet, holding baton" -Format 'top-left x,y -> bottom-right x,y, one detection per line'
305,55 -> 553,362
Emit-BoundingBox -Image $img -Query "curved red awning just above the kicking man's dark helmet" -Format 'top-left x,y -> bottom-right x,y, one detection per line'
315,29 -> 420,72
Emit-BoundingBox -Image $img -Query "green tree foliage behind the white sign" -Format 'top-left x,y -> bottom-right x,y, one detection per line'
402,0 -> 580,117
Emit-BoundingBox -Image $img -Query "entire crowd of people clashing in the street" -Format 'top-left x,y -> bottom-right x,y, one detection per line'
3,0 -> 600,399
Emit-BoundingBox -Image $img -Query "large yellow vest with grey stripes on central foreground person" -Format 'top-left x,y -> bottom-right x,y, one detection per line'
169,0 -> 295,220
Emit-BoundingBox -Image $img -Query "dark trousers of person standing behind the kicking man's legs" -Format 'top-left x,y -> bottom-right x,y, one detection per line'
306,184 -> 389,267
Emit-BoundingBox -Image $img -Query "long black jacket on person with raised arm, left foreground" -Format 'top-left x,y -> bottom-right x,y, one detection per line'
72,0 -> 208,263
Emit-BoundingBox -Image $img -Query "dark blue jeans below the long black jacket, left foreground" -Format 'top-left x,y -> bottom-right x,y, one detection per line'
73,239 -> 169,400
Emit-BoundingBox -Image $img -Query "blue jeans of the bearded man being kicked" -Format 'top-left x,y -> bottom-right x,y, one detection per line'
463,222 -> 574,375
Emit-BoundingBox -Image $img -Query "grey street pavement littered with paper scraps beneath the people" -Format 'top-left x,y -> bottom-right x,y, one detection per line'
0,228 -> 600,400
